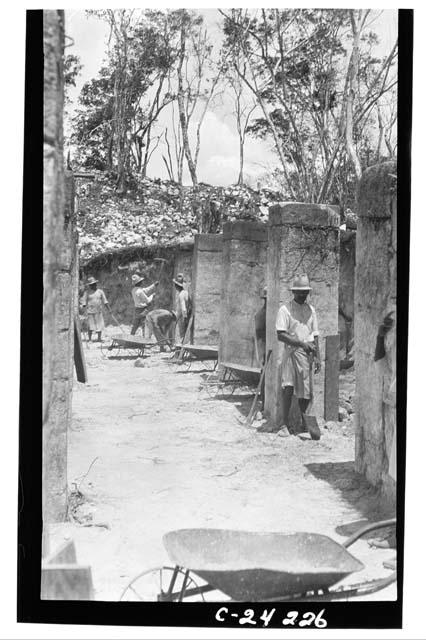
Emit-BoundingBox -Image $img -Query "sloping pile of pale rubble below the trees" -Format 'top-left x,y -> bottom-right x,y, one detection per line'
77,173 -> 282,262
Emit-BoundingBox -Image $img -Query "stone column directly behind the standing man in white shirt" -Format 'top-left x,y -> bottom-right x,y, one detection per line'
265,202 -> 339,426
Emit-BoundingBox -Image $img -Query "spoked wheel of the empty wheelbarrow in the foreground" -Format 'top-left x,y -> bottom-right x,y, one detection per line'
120,567 -> 204,602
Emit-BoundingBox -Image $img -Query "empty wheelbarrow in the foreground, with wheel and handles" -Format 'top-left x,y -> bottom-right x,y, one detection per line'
120,519 -> 396,602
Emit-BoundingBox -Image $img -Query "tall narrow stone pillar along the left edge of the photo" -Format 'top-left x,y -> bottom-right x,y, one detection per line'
42,11 -> 70,524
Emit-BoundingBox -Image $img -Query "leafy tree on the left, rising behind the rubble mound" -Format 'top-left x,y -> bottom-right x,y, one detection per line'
72,9 -> 178,192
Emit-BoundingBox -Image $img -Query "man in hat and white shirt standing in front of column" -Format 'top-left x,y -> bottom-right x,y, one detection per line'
260,274 -> 321,435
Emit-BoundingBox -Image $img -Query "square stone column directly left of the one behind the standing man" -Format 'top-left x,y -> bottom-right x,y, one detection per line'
219,221 -> 268,367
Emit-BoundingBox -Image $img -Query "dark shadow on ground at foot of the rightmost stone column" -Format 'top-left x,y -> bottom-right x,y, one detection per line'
305,460 -> 395,536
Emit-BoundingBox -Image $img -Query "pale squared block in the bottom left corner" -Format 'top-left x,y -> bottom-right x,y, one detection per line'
40,564 -> 93,600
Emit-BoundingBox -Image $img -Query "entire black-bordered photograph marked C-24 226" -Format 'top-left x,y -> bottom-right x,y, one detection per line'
13,6 -> 412,631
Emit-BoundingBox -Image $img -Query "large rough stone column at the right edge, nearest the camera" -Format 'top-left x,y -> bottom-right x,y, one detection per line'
355,162 -> 397,500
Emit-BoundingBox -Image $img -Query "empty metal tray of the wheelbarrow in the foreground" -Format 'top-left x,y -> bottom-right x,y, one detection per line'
163,529 -> 364,602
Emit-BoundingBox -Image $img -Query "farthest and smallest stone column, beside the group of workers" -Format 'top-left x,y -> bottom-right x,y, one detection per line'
192,233 -> 223,345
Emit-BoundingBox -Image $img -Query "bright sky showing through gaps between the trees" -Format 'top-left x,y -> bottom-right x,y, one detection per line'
65,9 -> 398,186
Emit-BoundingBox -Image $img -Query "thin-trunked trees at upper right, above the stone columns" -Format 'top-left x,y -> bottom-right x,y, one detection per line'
221,9 -> 397,208
